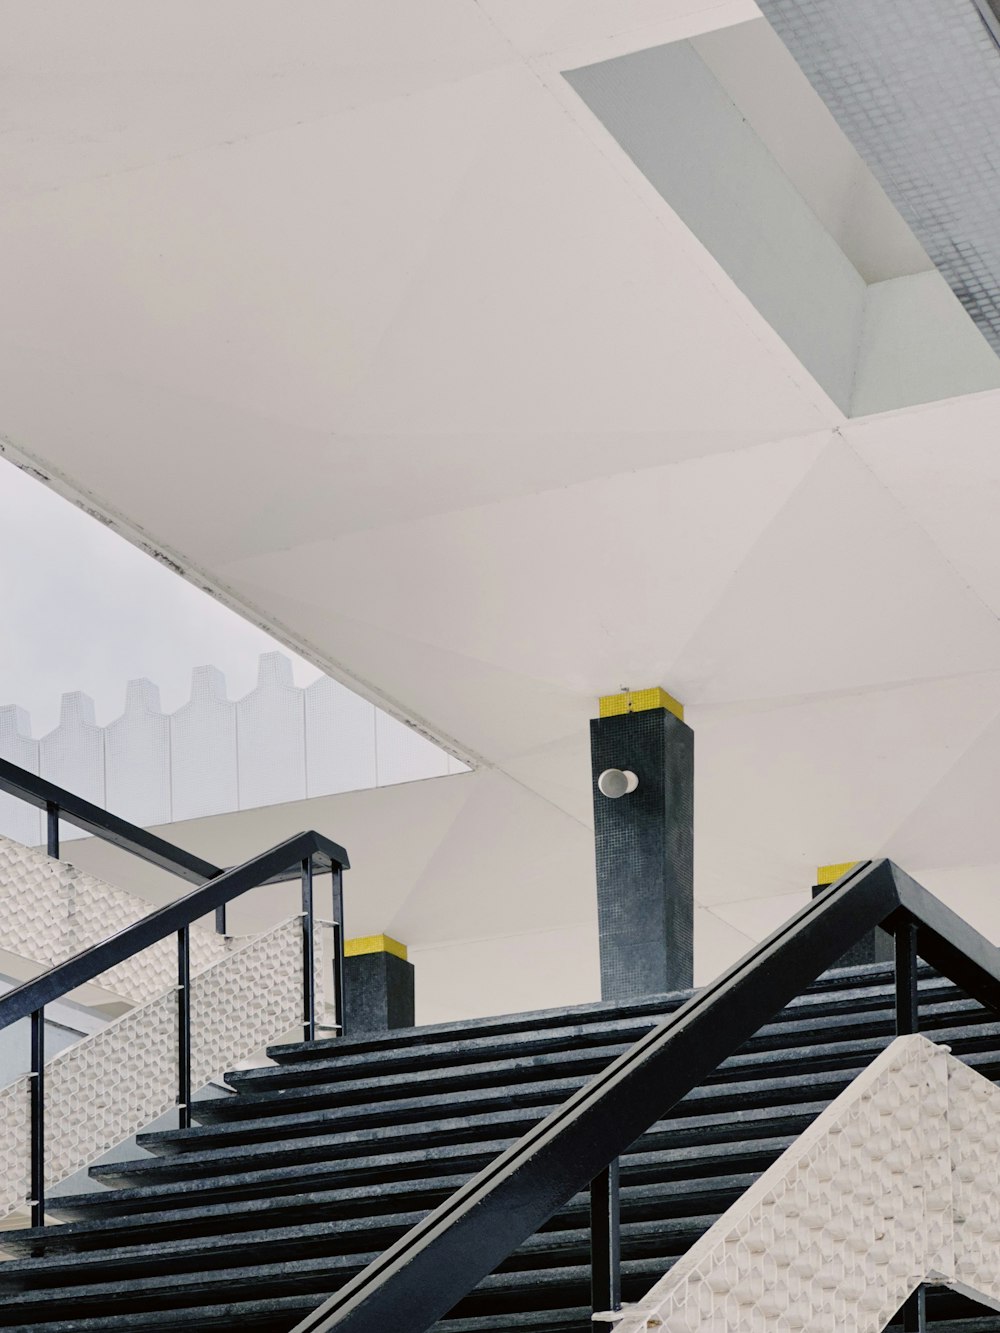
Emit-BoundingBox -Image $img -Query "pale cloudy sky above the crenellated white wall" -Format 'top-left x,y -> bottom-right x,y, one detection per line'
0,459 -> 320,737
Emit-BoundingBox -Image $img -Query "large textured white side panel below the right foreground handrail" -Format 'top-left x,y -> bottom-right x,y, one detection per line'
596,1036 -> 1000,1333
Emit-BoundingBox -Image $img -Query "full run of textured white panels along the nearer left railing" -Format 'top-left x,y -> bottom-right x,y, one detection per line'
0,917 -> 303,1217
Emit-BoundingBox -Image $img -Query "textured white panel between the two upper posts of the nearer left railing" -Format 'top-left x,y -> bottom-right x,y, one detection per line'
191,916 -> 304,1088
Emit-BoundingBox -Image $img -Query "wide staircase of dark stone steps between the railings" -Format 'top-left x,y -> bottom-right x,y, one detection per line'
0,966 -> 1000,1333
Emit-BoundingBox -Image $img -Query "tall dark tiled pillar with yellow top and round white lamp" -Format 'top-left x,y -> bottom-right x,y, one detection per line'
591,689 -> 695,1000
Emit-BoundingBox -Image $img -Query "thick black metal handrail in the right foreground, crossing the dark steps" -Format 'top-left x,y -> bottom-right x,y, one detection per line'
293,860 -> 1000,1333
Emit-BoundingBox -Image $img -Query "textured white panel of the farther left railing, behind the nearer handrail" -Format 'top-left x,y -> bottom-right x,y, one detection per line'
0,837 -> 227,1001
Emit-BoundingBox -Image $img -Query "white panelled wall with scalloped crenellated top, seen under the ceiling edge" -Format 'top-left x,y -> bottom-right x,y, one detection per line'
0,653 -> 467,842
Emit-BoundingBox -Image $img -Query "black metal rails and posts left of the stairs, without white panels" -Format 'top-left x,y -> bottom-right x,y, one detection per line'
0,760 -> 351,1226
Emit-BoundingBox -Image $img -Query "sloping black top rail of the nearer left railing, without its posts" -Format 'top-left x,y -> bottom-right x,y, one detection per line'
0,812 -> 351,1032
